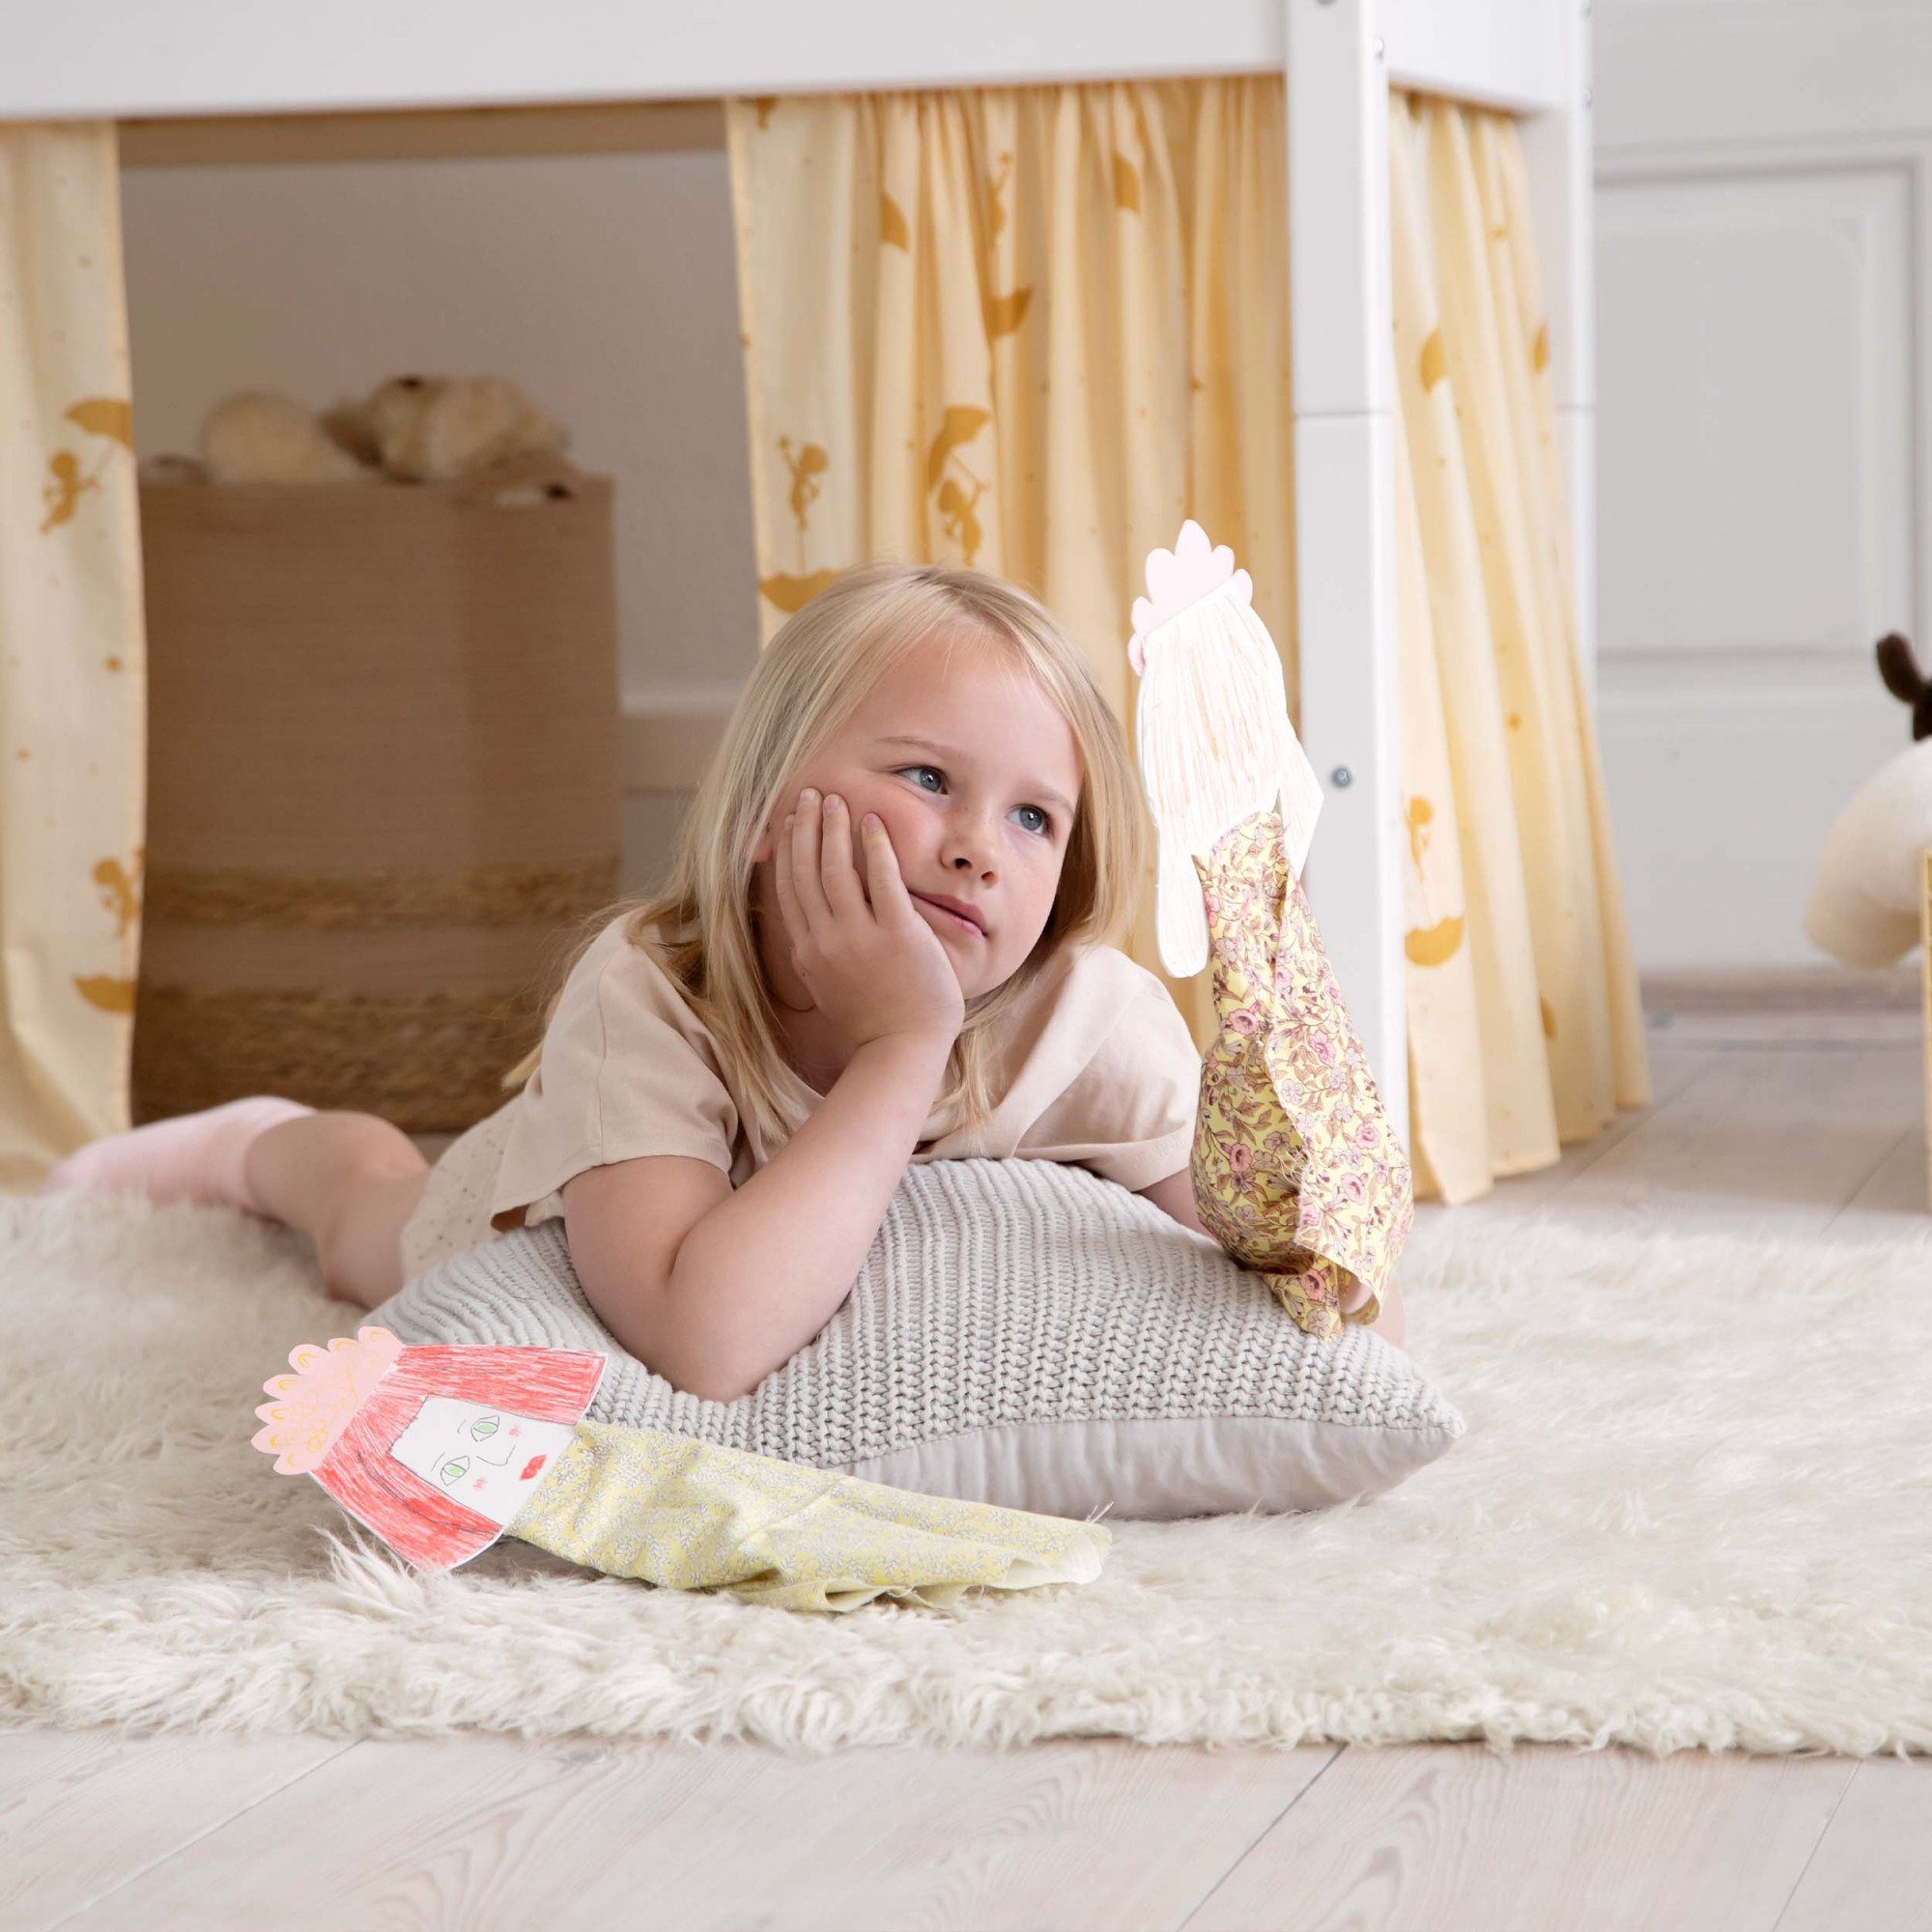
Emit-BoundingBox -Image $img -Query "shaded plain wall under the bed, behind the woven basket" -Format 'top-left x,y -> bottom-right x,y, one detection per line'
122,149 -> 757,889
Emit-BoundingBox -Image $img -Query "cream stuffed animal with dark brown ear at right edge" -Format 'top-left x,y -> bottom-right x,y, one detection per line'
1804,632 -> 1932,966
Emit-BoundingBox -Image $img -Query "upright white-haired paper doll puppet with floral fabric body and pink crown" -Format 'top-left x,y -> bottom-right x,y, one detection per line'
1126,522 -> 1414,1339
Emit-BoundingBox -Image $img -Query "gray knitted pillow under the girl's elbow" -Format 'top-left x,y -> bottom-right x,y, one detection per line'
367,1159 -> 1466,1517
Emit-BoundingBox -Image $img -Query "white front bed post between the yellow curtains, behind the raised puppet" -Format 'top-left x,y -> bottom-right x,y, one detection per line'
1283,0 -> 1408,1146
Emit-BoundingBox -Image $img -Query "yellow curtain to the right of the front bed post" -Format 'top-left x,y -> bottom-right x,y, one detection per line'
1389,95 -> 1650,1202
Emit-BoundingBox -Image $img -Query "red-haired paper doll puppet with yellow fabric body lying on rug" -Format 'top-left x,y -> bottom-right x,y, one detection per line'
253,1327 -> 1111,1609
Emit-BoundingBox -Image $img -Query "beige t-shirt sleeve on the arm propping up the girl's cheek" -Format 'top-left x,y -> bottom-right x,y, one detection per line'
491,920 -> 738,1219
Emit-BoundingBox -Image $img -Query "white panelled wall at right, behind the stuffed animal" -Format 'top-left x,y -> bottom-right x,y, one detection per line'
1594,0 -> 1932,966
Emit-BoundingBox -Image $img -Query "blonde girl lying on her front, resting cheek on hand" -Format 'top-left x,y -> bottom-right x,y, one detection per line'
46,564 -> 1401,1401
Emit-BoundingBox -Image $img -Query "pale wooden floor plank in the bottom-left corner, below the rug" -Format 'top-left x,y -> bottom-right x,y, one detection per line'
0,1729 -> 354,1932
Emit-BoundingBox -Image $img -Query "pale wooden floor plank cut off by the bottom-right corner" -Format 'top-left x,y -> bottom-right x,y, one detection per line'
1777,1758 -> 1932,1932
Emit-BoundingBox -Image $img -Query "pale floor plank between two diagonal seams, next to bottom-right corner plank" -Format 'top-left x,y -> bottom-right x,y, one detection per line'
1186,1745 -> 1857,1932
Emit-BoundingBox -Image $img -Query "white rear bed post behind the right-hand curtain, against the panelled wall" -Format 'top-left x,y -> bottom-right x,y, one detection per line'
1519,0 -> 1596,701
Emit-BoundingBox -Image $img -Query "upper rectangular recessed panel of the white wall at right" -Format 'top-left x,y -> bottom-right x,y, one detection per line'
1598,168 -> 1913,653
